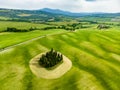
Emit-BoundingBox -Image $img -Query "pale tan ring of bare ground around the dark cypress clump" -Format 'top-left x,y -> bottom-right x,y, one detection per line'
30,53 -> 72,79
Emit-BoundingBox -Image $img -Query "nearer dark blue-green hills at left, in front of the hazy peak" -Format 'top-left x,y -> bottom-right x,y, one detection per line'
0,8 -> 69,22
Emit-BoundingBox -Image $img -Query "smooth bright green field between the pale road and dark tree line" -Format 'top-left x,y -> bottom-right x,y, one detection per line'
0,29 -> 66,49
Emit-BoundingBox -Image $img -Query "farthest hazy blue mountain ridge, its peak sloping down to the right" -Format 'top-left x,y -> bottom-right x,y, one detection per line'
40,8 -> 120,17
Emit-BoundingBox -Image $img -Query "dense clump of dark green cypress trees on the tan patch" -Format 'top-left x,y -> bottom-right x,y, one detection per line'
39,49 -> 63,68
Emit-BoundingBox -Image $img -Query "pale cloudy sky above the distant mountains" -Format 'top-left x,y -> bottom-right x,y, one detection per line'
0,0 -> 120,12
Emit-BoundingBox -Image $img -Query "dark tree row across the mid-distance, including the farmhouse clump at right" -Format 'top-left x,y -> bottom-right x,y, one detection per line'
3,23 -> 110,32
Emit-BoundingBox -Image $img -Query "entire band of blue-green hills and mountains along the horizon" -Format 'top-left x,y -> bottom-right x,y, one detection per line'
0,8 -> 120,22
